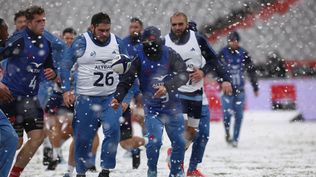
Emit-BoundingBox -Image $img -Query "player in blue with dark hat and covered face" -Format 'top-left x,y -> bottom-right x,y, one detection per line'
112,26 -> 188,177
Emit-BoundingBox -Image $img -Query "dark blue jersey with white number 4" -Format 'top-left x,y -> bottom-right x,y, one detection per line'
1,28 -> 53,96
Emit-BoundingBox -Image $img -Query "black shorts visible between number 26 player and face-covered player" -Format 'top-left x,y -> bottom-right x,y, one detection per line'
120,106 -> 133,141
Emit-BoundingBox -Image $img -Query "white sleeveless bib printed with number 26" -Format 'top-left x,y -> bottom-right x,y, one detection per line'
76,32 -> 119,96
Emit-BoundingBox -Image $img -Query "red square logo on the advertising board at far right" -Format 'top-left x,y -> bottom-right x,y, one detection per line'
271,84 -> 296,109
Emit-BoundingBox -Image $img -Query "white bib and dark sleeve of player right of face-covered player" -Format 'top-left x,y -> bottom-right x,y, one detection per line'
165,30 -> 230,94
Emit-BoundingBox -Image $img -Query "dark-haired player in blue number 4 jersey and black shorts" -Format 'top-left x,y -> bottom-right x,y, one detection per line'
0,6 -> 57,177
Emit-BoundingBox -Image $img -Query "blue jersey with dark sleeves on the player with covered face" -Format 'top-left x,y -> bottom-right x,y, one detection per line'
115,45 -> 188,113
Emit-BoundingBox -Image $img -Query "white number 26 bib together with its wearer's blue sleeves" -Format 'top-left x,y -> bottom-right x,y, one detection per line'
61,32 -> 127,96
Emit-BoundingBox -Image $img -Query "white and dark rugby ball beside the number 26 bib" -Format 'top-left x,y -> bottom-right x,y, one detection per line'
111,54 -> 132,74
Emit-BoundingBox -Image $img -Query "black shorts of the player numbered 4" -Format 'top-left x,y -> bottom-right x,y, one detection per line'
0,96 -> 44,137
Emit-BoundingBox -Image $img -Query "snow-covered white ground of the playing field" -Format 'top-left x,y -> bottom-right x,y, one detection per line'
22,111 -> 316,177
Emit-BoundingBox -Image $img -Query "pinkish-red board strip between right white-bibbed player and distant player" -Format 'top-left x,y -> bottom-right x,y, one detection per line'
204,79 -> 223,122
